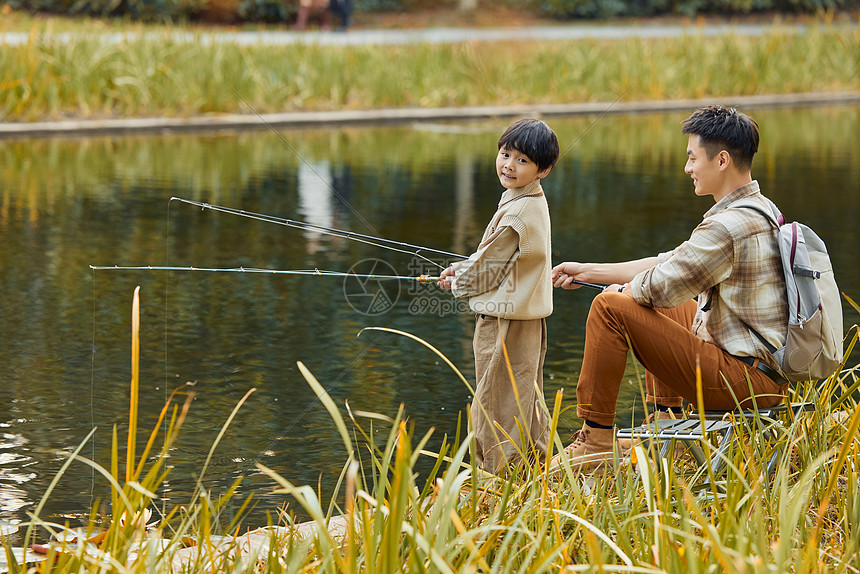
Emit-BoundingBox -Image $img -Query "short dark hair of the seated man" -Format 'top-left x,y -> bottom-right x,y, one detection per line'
681,105 -> 759,170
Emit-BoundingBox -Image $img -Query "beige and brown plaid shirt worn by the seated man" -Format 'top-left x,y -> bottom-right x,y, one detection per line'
631,181 -> 788,368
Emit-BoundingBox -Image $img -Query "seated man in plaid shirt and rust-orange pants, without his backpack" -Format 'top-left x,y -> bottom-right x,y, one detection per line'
552,106 -> 788,470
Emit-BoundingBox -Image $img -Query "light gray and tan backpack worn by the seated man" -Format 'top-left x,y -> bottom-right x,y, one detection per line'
729,198 -> 842,381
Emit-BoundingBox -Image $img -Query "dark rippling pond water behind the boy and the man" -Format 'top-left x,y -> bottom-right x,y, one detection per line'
0,106 -> 860,525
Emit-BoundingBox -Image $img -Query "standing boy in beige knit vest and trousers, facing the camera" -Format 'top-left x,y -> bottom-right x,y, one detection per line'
439,119 -> 559,473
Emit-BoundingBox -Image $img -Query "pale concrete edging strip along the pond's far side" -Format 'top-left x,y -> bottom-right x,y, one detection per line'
0,91 -> 860,140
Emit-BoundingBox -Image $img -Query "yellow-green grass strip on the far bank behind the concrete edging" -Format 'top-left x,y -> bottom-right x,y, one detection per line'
0,20 -> 860,121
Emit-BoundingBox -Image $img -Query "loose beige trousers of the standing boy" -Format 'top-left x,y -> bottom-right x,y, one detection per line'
471,315 -> 549,473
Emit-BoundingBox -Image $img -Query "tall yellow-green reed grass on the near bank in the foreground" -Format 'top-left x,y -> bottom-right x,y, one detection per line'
3,292 -> 860,573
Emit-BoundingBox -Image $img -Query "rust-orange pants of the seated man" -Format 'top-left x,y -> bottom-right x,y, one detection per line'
576,292 -> 788,425
